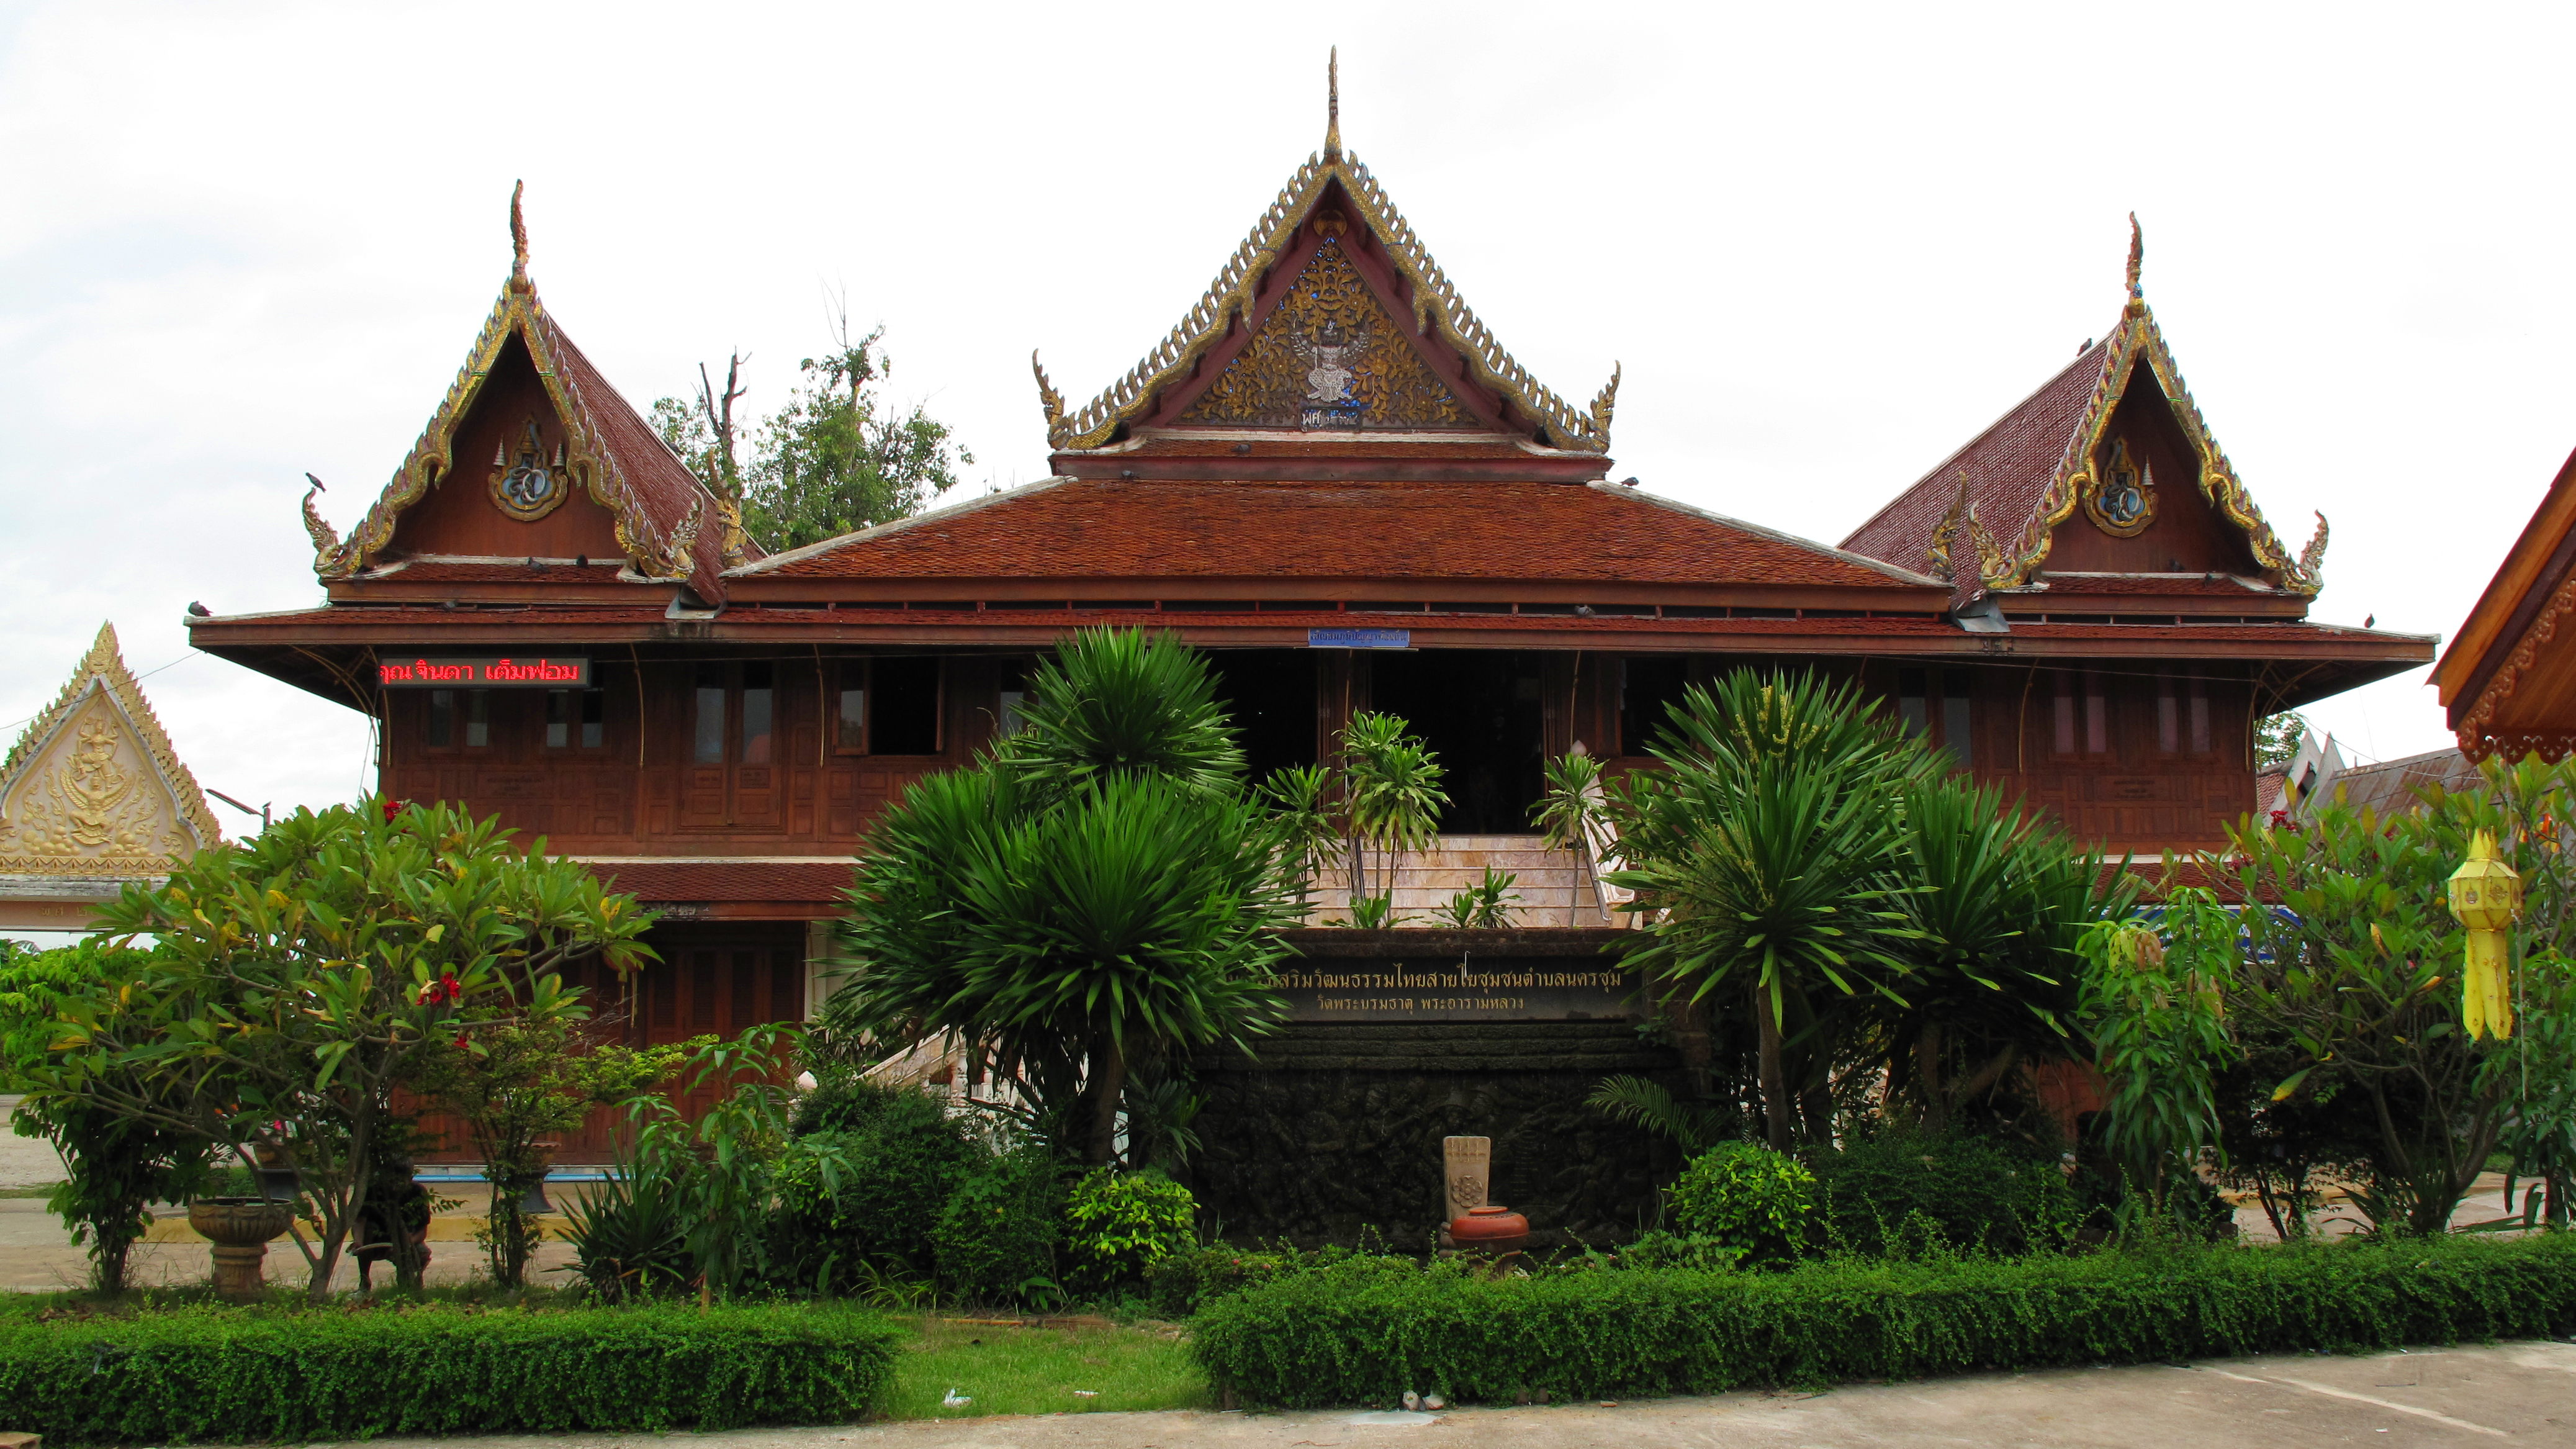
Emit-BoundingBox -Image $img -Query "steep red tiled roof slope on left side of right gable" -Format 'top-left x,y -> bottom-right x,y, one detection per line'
1842,338 -> 2112,590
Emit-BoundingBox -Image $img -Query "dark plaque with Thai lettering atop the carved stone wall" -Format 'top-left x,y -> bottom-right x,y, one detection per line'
1281,957 -> 1638,1021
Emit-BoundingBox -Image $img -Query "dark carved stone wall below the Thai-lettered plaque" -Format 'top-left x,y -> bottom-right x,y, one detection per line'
1185,1021 -> 1682,1250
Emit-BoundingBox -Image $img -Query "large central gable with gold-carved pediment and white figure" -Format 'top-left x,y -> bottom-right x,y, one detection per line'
1030,57 -> 1618,454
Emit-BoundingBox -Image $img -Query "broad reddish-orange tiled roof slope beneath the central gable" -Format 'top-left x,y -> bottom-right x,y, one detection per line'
734,479 -> 1937,590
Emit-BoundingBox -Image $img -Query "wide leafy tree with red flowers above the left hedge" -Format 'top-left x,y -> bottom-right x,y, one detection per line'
23,802 -> 654,1297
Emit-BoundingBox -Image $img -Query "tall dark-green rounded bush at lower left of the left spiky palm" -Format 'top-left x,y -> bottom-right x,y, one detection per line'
773,1091 -> 981,1273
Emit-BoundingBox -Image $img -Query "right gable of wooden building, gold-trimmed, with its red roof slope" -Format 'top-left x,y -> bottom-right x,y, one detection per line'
1842,217 -> 2326,595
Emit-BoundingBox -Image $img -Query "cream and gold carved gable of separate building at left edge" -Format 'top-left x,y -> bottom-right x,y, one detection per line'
0,624 -> 224,882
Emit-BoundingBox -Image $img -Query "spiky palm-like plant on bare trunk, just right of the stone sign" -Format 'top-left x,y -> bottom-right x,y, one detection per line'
1605,670 -> 1935,1150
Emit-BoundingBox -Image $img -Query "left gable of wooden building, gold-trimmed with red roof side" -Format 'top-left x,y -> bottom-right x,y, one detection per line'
304,191 -> 757,601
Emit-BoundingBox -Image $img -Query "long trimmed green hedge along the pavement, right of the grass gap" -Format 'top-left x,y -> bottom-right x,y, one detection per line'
1192,1235 -> 2576,1408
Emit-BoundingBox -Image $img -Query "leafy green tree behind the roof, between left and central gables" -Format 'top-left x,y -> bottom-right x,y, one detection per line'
742,315 -> 974,552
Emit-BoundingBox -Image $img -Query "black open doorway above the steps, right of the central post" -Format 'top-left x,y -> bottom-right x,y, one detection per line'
1368,650 -> 1548,836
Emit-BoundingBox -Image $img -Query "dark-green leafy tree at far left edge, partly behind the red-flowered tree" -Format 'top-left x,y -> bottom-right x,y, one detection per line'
0,939 -> 214,1294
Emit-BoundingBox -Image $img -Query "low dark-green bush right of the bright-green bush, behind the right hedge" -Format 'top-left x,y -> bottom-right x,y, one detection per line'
1811,1132 -> 2084,1256
